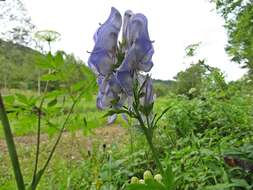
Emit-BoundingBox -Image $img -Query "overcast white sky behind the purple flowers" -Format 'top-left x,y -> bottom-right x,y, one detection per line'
22,0 -> 245,80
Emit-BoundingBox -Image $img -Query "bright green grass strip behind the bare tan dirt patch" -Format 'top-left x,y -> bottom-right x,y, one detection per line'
0,89 -> 106,138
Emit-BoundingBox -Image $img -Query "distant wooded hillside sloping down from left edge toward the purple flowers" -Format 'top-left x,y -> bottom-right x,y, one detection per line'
0,39 -> 91,90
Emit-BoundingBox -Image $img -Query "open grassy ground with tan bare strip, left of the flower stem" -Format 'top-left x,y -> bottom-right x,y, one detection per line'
0,89 -> 132,190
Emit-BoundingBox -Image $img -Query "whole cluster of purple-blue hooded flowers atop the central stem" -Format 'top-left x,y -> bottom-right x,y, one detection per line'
88,7 -> 154,109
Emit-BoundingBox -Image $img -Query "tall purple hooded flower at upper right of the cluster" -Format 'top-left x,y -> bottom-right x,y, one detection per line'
117,14 -> 154,95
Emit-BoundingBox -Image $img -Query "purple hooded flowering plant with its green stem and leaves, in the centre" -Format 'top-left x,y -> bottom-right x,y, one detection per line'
88,7 -> 172,189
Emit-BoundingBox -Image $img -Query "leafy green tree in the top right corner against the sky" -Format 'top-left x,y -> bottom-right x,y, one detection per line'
212,0 -> 253,77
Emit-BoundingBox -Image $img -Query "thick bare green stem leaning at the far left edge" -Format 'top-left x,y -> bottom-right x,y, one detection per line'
0,92 -> 25,190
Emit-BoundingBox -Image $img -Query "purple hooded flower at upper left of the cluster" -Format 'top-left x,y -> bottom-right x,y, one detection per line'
88,7 -> 122,76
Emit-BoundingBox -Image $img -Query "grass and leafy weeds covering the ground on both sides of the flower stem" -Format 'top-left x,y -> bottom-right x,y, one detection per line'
0,88 -> 253,190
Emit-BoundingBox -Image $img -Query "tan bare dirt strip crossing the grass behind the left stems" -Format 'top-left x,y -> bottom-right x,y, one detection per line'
0,124 -> 126,159
